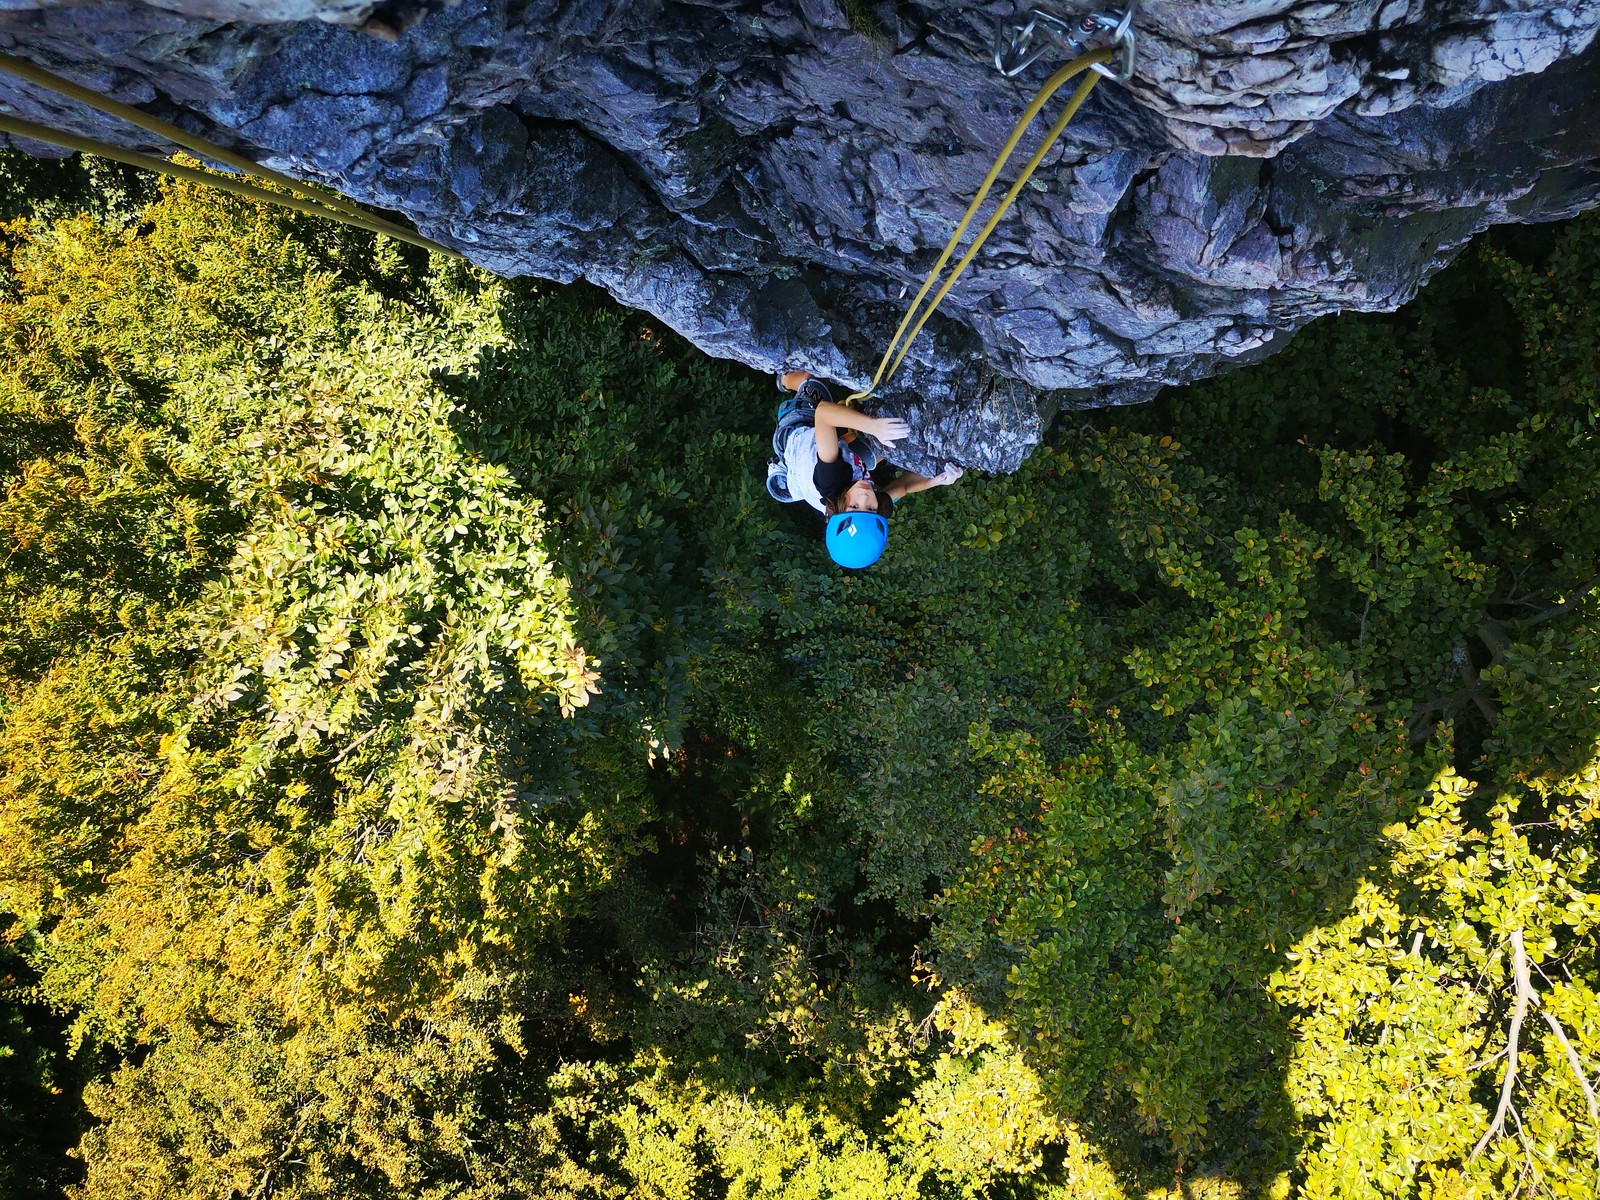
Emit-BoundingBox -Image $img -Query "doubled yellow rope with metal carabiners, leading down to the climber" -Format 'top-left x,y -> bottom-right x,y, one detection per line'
845,2 -> 1134,403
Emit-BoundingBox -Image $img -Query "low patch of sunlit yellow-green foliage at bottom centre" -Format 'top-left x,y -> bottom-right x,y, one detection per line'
537,992 -> 1118,1200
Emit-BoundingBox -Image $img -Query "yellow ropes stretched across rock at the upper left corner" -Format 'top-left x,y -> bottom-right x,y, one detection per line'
0,53 -> 461,258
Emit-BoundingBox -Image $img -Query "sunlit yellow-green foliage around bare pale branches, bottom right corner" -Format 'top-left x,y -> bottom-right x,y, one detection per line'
1272,766 -> 1600,1198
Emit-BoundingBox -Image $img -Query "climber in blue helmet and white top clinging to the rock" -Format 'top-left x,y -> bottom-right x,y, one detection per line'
766,371 -> 962,568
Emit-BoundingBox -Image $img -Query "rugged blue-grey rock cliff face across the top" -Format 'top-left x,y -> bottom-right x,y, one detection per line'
0,0 -> 1600,469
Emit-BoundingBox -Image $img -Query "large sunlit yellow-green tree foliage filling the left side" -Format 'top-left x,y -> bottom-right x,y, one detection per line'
0,187 -> 643,1195
